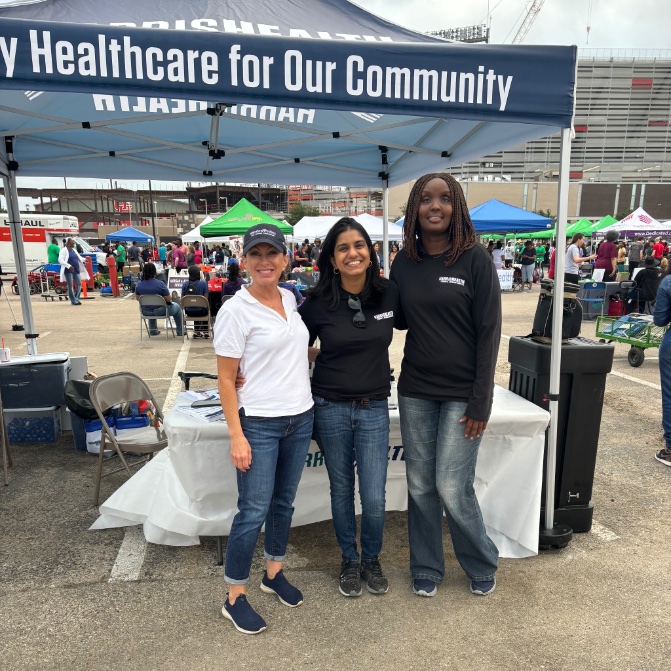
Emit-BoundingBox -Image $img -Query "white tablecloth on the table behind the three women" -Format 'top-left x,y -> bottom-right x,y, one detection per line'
91,387 -> 550,557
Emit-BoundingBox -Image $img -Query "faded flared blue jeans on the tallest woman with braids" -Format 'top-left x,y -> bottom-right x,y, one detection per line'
398,394 -> 499,582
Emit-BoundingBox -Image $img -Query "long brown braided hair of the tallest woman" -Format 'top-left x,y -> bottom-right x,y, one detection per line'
403,172 -> 475,266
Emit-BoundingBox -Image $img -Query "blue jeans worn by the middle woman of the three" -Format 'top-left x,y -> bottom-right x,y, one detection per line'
313,396 -> 389,562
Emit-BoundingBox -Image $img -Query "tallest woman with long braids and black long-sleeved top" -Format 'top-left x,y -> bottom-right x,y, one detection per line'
391,173 -> 501,597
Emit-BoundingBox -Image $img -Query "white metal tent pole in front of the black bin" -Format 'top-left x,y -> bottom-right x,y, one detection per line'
545,128 -> 571,530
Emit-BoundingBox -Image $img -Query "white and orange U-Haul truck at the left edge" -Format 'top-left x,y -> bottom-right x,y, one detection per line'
0,217 -> 105,274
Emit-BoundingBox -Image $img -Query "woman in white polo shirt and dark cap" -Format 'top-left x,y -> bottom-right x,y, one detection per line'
214,224 -> 313,634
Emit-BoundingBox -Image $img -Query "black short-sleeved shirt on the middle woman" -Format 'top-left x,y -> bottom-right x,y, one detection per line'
298,284 -> 398,401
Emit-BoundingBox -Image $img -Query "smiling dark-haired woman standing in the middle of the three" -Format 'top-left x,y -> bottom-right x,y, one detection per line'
299,217 -> 397,596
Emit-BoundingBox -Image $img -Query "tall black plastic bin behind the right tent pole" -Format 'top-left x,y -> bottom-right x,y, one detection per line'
508,337 -> 615,532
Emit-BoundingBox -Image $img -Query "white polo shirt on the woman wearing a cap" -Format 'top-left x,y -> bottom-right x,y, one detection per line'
214,285 -> 313,417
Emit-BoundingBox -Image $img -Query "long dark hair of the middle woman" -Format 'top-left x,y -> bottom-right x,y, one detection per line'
309,217 -> 389,310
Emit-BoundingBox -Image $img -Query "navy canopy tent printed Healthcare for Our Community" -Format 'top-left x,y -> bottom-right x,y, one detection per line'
0,0 -> 576,540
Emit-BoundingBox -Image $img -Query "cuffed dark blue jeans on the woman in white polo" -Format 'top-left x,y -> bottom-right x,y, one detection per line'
224,408 -> 313,585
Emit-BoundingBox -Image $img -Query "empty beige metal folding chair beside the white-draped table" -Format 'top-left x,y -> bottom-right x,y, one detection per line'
91,373 -> 168,506
